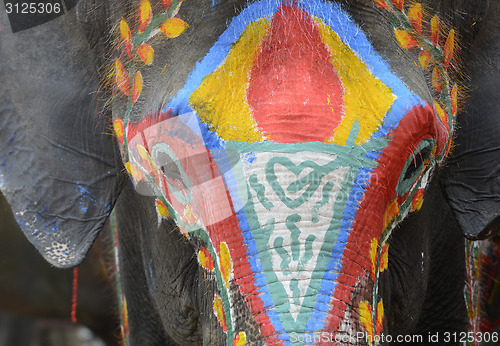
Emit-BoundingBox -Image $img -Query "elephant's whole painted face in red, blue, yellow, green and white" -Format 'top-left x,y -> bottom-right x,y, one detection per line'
115,0 -> 456,343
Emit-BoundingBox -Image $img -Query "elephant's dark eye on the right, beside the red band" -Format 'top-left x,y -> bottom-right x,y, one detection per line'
396,139 -> 434,196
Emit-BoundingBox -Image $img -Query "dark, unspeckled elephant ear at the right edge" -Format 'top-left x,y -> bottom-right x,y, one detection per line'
442,2 -> 500,239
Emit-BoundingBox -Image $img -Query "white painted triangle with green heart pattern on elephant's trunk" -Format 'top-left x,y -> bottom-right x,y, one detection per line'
244,152 -> 349,321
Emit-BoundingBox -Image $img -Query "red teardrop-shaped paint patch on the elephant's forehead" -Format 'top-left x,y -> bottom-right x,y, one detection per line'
247,5 -> 344,143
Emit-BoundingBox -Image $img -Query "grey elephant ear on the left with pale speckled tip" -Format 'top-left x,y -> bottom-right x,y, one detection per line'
0,6 -> 122,267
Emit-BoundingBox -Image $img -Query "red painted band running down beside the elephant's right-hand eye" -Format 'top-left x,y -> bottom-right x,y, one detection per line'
325,105 -> 446,331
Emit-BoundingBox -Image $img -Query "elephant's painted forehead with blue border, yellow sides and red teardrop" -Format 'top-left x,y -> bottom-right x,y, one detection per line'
166,1 -> 430,145
